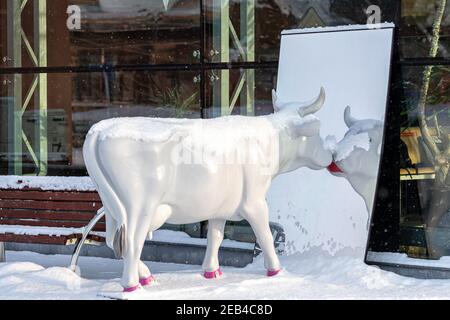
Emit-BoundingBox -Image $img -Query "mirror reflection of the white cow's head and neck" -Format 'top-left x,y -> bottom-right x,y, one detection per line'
327,107 -> 383,228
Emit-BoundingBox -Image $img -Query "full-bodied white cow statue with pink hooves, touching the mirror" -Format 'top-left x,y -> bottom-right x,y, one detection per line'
83,88 -> 332,292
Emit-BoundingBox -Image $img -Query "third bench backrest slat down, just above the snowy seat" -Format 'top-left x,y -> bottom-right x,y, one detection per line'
0,209 -> 104,224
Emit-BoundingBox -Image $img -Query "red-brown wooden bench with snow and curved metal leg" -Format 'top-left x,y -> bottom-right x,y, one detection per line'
0,176 -> 105,268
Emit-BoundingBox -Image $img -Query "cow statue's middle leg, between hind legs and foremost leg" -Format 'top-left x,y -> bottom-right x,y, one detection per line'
202,219 -> 226,279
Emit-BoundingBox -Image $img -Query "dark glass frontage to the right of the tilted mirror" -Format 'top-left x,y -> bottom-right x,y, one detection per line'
366,0 -> 450,267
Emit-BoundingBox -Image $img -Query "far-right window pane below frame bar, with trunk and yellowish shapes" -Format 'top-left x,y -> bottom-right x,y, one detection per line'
400,66 -> 450,258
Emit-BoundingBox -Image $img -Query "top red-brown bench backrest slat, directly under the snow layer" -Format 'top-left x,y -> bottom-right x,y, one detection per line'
0,189 -> 100,202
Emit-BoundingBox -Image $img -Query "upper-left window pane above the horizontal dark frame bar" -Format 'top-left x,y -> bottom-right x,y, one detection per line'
0,0 -> 201,67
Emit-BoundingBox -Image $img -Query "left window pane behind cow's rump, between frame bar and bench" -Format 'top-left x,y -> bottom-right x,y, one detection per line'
0,71 -> 201,176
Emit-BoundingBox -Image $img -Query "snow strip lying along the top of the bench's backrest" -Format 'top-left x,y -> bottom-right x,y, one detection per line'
0,176 -> 96,191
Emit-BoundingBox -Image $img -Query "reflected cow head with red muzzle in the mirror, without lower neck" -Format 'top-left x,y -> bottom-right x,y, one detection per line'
328,107 -> 383,179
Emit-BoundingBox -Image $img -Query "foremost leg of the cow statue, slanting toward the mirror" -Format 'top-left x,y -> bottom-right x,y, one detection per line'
245,200 -> 280,276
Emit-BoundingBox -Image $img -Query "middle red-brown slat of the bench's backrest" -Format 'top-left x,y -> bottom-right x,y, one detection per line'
0,200 -> 102,212
